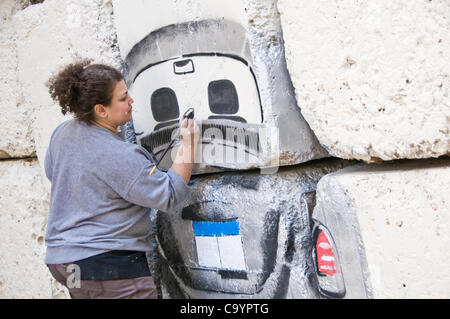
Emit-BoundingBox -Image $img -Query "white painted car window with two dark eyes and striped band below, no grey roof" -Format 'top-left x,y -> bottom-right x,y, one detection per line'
130,54 -> 263,167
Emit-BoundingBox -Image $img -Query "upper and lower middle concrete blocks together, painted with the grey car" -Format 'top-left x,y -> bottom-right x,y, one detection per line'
113,0 -> 332,298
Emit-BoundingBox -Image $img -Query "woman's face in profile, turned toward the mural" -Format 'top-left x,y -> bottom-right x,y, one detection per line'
105,80 -> 134,126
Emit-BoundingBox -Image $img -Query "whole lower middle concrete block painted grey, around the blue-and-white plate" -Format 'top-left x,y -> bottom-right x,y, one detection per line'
151,159 -> 349,298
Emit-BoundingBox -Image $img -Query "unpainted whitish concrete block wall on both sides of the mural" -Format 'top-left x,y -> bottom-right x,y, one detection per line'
0,0 -> 450,298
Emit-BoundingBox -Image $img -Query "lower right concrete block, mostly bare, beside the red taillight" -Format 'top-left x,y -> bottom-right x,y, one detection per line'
313,157 -> 450,298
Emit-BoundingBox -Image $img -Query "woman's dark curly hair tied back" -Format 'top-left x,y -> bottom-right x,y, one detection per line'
47,60 -> 123,123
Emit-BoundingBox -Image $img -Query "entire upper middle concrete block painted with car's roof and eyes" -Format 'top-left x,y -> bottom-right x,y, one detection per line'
113,0 -> 328,175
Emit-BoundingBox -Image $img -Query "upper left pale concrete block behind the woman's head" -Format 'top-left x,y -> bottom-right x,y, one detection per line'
0,0 -> 120,165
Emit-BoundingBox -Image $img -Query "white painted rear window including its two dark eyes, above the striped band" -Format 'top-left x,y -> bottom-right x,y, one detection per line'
133,55 -> 262,133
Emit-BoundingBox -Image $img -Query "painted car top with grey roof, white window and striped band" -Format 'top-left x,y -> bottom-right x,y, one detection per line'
125,20 -> 264,169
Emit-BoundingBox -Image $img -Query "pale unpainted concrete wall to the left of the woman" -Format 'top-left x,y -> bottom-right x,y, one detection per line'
0,0 -> 121,298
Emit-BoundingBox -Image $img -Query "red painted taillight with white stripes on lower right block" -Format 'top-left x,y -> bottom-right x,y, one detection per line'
312,224 -> 345,298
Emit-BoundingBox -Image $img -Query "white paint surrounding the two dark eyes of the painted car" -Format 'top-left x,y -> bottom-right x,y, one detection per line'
130,56 -> 261,141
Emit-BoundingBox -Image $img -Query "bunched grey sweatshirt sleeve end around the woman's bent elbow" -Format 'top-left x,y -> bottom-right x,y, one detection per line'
125,162 -> 189,212
